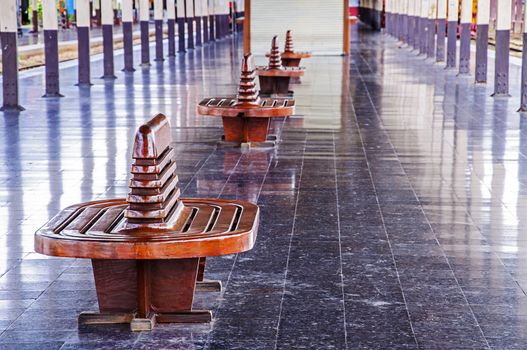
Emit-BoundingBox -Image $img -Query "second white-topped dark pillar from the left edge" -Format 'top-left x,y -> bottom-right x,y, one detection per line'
42,0 -> 62,97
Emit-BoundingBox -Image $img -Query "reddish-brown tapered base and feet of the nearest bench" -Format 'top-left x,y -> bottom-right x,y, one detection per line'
88,258 -> 212,331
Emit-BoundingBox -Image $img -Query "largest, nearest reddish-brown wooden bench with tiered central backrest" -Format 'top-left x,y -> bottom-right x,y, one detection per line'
35,114 -> 259,331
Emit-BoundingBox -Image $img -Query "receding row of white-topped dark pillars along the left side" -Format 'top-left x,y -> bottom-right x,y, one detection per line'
0,0 -> 243,111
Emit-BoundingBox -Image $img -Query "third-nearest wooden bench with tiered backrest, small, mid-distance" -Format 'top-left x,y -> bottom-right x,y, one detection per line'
256,35 -> 304,96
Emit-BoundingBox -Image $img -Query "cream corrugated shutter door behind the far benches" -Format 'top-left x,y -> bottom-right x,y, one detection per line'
251,0 -> 344,55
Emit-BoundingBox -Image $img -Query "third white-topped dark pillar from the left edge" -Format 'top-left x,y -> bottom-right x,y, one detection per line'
75,0 -> 92,86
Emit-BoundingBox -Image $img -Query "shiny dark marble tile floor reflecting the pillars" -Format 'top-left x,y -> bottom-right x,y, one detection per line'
0,23 -> 527,350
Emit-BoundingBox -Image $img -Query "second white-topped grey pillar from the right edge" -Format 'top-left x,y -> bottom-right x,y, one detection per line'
493,0 -> 512,96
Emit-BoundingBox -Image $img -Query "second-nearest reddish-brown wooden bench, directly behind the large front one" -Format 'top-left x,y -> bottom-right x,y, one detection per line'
197,54 -> 295,146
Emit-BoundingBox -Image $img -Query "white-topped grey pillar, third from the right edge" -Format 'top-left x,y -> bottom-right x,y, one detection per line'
476,0 -> 490,83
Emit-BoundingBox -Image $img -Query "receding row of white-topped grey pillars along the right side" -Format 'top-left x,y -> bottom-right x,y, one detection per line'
361,0 -> 527,111
